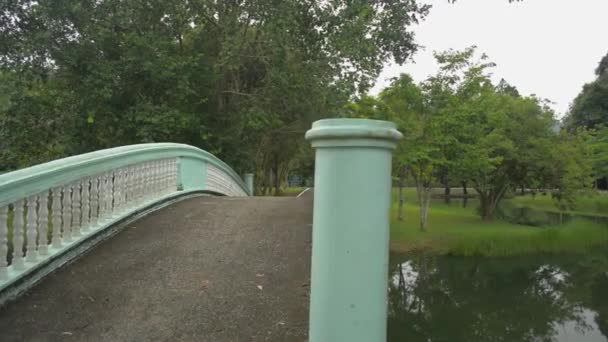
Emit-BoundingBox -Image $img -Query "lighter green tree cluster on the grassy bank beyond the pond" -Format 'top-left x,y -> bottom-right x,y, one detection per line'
347,46 -> 606,222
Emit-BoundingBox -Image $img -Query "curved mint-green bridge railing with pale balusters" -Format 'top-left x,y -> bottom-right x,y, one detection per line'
0,143 -> 251,298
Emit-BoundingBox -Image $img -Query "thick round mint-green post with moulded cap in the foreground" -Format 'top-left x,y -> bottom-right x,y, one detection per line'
306,119 -> 402,342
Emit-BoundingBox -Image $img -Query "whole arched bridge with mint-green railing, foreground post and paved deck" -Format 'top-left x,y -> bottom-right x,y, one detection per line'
0,119 -> 400,342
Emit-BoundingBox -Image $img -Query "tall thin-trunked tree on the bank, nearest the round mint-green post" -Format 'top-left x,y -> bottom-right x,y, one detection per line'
372,47 -> 492,231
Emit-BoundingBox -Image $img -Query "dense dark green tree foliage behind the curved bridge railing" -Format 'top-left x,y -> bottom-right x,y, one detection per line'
0,0 -> 429,182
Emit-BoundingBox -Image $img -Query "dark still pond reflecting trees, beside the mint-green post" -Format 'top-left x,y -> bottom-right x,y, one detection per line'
388,251 -> 608,342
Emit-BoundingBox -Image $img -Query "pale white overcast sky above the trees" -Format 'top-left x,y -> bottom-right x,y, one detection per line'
372,0 -> 608,117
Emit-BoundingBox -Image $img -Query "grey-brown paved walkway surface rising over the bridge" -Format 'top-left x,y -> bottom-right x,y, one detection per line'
0,191 -> 312,342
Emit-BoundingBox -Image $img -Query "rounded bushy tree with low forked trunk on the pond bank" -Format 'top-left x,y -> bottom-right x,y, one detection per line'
461,89 -> 554,220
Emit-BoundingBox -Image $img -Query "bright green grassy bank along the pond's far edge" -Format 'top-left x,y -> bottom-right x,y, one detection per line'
391,189 -> 608,256
